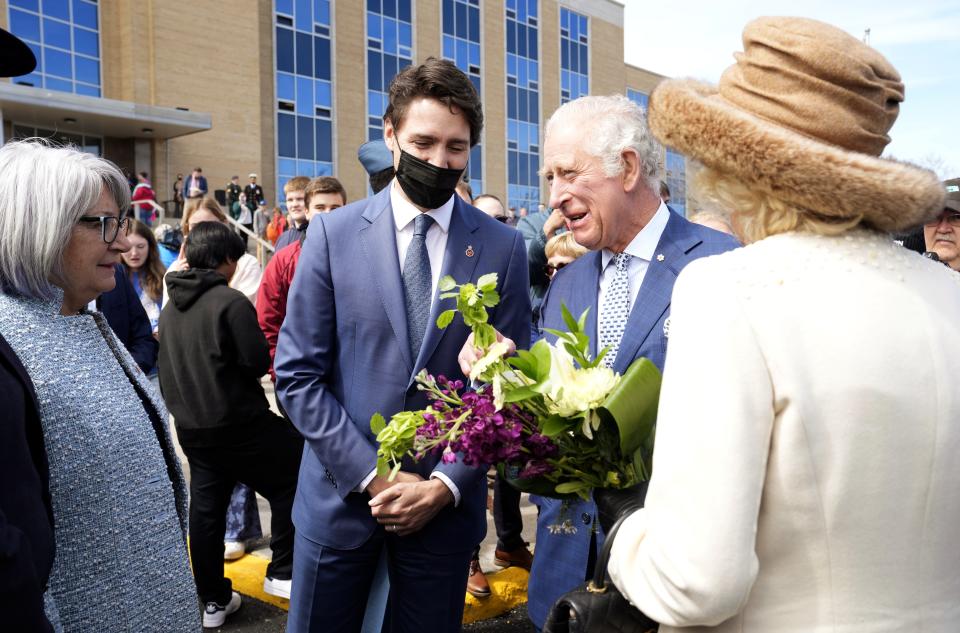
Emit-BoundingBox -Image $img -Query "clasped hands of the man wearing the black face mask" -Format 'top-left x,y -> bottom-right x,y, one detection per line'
366,471 -> 454,536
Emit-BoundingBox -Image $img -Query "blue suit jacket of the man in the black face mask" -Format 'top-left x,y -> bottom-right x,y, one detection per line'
274,188 -> 530,554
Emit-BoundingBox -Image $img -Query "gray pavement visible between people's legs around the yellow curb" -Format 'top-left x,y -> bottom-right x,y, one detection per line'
171,377 -> 537,633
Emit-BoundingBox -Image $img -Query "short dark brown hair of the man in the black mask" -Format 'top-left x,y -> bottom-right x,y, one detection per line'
383,57 -> 483,147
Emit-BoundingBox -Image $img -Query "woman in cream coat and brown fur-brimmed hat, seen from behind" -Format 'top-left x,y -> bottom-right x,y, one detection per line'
597,18 -> 960,633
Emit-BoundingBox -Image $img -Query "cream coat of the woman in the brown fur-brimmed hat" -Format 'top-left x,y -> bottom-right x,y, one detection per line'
609,232 -> 960,633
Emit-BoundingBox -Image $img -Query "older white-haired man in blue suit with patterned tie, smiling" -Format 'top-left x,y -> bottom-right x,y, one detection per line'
462,96 -> 738,628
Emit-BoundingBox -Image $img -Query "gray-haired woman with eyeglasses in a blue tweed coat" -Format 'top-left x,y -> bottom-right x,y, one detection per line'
0,141 -> 200,633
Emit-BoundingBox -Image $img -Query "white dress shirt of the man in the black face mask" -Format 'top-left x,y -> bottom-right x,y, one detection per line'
356,180 -> 460,507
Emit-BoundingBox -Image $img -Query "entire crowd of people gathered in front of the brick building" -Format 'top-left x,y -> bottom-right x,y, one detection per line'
0,13 -> 960,633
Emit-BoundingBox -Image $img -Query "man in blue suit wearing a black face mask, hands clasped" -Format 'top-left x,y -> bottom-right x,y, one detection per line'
275,58 -> 530,633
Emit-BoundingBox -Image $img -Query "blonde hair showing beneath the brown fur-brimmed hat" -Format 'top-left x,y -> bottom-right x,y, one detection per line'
696,167 -> 863,244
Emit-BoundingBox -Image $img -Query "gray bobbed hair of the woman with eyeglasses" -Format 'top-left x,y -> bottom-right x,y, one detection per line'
0,139 -> 130,299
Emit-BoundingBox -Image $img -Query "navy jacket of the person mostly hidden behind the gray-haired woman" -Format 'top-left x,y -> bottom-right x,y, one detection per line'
97,264 -> 160,374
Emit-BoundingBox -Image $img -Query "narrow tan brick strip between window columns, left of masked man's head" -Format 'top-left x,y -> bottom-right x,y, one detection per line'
331,2 -> 368,200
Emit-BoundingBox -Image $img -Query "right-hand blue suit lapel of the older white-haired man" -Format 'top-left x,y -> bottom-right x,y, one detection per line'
613,213 -> 701,373
